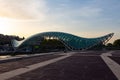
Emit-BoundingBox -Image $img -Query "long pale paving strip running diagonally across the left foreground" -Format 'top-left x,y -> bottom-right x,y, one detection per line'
0,53 -> 72,80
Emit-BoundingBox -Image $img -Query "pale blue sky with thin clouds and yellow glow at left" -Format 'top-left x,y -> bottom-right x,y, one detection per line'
0,0 -> 120,42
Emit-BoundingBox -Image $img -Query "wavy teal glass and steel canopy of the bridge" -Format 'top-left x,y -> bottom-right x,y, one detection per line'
13,32 -> 114,50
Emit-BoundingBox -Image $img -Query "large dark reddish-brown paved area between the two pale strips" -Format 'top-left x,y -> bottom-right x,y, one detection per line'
8,53 -> 118,80
